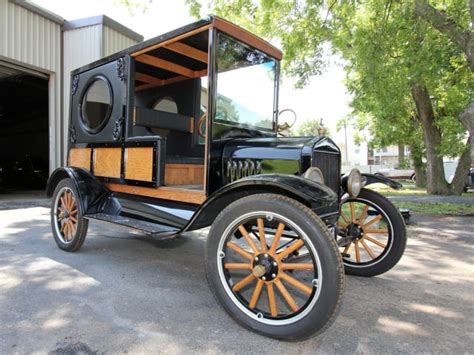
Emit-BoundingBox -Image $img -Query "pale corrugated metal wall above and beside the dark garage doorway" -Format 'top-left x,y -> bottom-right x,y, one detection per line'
0,0 -> 61,170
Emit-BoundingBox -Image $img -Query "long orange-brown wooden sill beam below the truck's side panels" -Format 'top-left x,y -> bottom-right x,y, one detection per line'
106,183 -> 206,205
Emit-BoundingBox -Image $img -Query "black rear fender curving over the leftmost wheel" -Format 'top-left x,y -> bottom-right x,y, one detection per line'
46,167 -> 110,216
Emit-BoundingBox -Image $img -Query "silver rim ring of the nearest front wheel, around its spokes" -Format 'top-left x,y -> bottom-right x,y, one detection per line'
216,211 -> 323,326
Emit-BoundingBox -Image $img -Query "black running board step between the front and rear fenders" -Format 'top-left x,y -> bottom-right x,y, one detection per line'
85,213 -> 179,237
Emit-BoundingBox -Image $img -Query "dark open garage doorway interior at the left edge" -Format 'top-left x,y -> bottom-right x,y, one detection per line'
0,65 -> 49,193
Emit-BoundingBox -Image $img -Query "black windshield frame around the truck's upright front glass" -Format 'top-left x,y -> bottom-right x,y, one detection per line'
208,30 -> 280,140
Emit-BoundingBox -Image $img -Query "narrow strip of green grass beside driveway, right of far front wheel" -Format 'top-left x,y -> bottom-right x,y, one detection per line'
392,201 -> 474,215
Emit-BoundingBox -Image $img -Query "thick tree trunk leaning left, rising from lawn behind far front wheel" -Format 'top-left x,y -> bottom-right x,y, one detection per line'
412,84 -> 451,195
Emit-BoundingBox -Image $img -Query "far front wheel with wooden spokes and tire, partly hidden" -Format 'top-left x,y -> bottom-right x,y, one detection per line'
337,189 -> 406,276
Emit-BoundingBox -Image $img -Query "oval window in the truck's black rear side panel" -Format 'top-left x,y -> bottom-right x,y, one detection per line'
82,78 -> 112,133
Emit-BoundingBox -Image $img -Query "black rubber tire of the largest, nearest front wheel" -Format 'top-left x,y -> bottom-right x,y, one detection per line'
206,194 -> 344,341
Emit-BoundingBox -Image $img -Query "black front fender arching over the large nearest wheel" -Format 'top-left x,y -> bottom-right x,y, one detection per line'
182,174 -> 339,232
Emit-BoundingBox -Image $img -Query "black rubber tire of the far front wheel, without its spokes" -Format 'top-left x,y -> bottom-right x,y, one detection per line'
343,189 -> 407,277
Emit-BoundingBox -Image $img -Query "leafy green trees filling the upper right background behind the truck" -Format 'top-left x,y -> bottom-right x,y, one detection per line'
187,0 -> 474,193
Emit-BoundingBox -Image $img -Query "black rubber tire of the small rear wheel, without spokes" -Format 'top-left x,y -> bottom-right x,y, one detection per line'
50,178 -> 89,252
